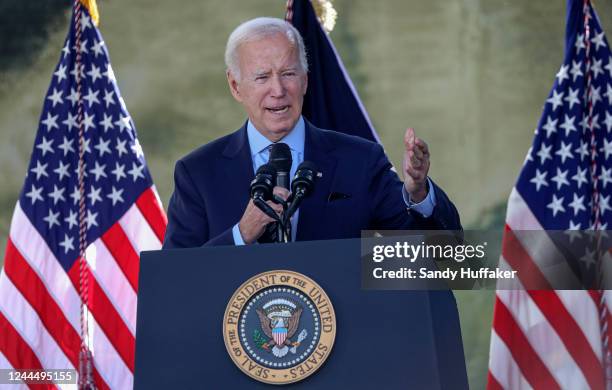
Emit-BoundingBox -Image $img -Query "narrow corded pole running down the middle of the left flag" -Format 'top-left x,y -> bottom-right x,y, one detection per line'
74,0 -> 95,390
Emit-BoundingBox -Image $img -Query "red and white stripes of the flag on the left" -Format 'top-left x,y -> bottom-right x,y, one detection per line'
0,187 -> 167,389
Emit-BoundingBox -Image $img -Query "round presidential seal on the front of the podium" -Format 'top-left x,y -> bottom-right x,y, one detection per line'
223,270 -> 336,384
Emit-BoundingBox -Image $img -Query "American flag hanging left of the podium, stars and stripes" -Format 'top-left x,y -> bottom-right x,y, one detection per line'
0,2 -> 166,389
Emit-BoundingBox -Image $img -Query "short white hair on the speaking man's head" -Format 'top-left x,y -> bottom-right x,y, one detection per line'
225,17 -> 308,80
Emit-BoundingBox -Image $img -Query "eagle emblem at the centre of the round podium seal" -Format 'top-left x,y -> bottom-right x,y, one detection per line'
253,298 -> 308,358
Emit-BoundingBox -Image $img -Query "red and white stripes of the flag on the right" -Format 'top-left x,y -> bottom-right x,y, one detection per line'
487,189 -> 612,389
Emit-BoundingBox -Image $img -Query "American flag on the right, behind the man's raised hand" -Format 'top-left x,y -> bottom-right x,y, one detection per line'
488,0 -> 612,389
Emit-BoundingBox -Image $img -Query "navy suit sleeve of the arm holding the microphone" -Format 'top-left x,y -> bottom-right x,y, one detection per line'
163,160 -> 234,249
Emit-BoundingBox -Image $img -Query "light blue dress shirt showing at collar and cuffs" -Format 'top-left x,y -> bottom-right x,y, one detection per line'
232,116 -> 436,245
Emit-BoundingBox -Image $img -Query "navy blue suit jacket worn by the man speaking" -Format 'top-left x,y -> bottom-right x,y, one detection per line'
164,121 -> 461,248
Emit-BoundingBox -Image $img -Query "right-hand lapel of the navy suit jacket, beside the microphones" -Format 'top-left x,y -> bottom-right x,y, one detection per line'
296,120 -> 337,241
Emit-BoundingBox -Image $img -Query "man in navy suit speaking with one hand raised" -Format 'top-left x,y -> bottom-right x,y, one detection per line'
164,18 -> 461,248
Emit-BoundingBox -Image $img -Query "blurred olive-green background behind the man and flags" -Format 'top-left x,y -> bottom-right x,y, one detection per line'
0,0 -> 612,389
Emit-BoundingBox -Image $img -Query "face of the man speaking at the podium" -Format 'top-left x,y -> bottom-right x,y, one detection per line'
227,34 -> 308,142
